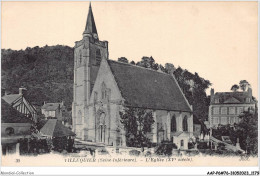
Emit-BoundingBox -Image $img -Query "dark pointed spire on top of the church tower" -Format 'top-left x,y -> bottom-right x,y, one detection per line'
83,3 -> 98,38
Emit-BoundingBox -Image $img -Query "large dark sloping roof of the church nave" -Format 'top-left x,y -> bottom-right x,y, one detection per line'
108,60 -> 192,112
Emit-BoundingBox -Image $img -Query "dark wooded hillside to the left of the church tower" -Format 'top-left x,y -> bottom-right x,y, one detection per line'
1,45 -> 74,108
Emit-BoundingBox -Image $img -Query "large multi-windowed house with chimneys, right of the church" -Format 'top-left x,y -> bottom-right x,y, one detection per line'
209,88 -> 257,128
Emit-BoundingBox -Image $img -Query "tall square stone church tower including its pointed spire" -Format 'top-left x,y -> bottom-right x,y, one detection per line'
72,4 -> 108,140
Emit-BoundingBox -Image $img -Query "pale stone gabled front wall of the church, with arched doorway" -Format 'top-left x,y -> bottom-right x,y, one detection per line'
86,59 -> 122,145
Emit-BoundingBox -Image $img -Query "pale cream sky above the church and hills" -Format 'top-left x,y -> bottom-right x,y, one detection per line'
1,2 -> 258,98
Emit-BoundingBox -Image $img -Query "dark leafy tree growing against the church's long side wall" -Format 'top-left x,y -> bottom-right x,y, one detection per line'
119,107 -> 154,148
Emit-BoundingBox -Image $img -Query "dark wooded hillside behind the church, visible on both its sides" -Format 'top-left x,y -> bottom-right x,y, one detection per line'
1,45 -> 211,120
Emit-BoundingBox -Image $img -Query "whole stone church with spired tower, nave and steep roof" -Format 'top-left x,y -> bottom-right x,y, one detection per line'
72,5 -> 193,149
